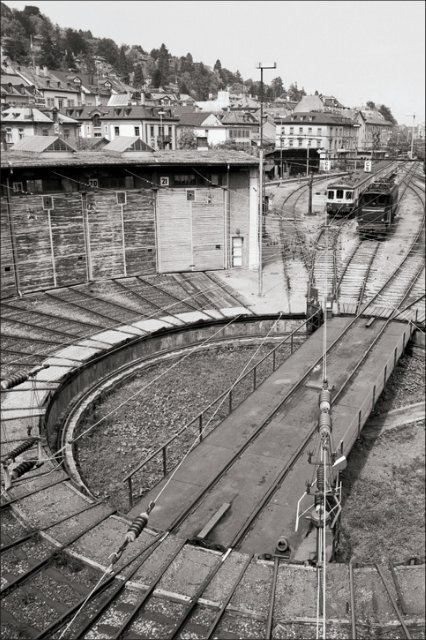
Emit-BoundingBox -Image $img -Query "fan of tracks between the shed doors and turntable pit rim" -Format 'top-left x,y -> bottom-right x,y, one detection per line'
1,273 -> 246,378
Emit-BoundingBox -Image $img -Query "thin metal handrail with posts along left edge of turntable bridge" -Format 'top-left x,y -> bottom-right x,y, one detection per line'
122,314 -> 315,507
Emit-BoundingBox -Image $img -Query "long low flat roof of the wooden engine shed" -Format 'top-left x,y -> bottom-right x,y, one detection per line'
1,148 -> 259,169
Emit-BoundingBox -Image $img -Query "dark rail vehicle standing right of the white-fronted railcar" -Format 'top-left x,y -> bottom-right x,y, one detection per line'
358,174 -> 398,238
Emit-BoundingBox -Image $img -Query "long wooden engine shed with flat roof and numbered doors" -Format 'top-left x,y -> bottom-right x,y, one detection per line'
1,141 -> 259,297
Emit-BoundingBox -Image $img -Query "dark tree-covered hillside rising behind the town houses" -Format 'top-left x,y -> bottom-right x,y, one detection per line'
1,2 -> 305,101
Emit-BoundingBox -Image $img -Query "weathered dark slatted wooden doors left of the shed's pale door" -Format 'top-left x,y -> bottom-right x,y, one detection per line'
1,189 -> 156,297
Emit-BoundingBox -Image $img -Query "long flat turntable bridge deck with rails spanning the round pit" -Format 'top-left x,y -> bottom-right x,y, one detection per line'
129,316 -> 412,561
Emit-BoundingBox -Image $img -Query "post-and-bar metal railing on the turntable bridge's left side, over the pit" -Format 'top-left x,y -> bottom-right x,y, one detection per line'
123,318 -> 311,508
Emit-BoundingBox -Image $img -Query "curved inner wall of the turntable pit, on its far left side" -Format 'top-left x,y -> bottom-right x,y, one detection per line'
42,315 -> 306,450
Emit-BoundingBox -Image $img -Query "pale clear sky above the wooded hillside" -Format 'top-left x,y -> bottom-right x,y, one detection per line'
5,0 -> 425,125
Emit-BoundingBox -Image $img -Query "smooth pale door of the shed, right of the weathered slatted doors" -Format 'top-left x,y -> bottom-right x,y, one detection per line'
157,187 -> 225,273
